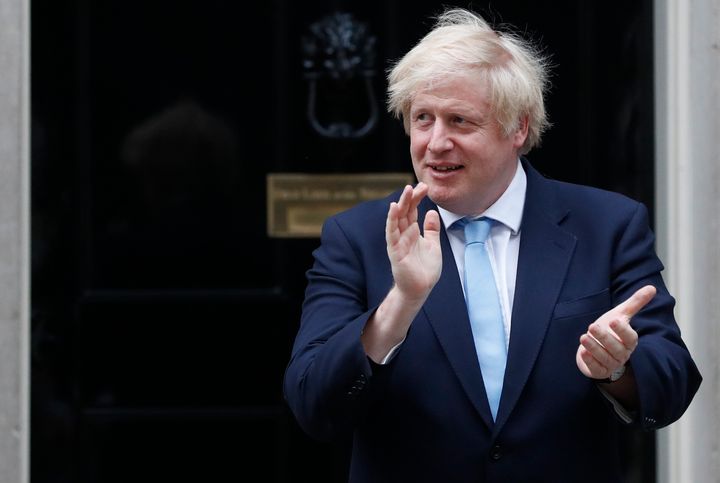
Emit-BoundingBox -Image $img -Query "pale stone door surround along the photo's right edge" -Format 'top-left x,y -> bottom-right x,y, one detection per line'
655,0 -> 720,483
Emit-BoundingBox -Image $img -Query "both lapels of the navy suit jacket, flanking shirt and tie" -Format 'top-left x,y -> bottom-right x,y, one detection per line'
418,162 -> 576,435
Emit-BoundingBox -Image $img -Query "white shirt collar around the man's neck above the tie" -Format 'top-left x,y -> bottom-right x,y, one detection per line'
438,160 -> 527,235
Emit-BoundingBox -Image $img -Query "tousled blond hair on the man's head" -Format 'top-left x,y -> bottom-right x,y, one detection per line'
388,9 -> 550,154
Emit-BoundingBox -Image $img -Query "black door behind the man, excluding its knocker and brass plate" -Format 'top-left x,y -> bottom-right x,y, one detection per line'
32,0 -> 654,483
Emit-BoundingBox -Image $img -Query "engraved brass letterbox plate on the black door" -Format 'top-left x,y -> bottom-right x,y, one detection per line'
267,173 -> 415,238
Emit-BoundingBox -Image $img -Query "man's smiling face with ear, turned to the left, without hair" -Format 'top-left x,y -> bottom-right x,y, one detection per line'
409,77 -> 527,215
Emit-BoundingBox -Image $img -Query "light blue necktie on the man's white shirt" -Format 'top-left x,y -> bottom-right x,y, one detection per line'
463,218 -> 507,420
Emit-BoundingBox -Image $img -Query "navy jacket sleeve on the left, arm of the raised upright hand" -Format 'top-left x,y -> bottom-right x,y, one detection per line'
284,218 -> 382,440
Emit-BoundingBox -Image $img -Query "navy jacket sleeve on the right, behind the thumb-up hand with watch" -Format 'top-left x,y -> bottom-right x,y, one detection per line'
613,204 -> 702,429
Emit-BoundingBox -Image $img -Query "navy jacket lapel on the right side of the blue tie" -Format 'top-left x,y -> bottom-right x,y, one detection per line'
493,163 -> 576,434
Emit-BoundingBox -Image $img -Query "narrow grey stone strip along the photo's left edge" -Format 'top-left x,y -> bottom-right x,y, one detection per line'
0,0 -> 30,483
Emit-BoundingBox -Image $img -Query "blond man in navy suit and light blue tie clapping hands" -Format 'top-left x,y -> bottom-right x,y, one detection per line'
284,10 -> 701,483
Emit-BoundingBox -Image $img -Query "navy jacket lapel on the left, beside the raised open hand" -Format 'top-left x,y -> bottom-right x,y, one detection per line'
419,202 -> 493,428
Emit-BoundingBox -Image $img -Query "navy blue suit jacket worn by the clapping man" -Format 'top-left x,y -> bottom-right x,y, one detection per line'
284,161 -> 701,483
